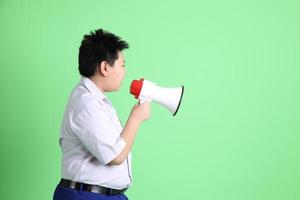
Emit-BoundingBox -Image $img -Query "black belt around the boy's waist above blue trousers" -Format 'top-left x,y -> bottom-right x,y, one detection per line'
59,179 -> 127,195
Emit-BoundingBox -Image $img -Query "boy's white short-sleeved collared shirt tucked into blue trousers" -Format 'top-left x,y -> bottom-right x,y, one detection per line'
59,77 -> 131,189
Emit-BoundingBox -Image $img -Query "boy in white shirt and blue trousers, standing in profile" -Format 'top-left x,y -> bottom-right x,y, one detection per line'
53,29 -> 150,200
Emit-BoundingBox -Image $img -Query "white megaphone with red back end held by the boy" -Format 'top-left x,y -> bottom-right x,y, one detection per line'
130,78 -> 184,116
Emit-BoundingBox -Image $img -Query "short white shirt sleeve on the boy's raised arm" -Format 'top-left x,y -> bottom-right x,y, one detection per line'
72,106 -> 126,165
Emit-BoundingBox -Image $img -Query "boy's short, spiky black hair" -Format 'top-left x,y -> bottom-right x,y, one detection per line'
78,29 -> 129,77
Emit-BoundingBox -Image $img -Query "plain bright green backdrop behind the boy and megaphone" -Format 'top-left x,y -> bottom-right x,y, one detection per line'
0,0 -> 300,200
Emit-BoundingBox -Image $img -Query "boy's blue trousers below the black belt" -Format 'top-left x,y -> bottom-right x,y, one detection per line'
53,185 -> 128,200
